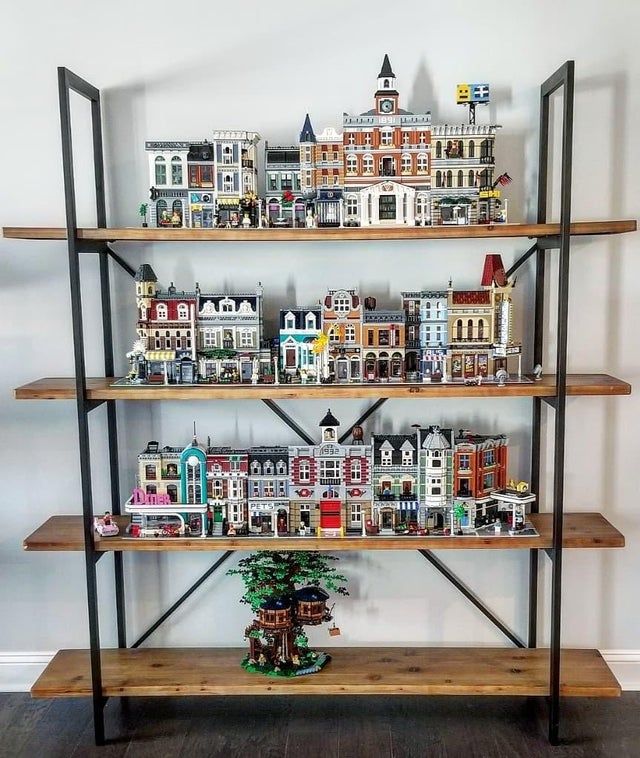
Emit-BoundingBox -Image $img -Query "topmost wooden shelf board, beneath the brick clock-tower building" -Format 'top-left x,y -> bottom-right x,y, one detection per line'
2,219 -> 637,242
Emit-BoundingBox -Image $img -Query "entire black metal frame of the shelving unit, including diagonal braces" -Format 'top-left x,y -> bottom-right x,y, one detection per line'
58,61 -> 574,745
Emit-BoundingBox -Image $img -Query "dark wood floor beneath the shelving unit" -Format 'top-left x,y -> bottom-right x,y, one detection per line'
0,693 -> 640,758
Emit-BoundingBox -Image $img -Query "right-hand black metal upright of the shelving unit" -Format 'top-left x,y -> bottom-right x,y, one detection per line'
535,61 -> 574,745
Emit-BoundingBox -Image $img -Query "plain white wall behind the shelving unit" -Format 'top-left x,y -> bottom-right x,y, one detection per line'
0,0 -> 640,686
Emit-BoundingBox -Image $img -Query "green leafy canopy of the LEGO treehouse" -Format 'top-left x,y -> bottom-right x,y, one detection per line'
227,550 -> 349,611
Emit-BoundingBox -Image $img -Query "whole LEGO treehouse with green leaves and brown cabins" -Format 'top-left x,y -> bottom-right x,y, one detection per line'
228,551 -> 348,676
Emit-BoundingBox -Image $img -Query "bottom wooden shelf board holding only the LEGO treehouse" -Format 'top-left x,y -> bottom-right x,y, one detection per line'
31,647 -> 620,698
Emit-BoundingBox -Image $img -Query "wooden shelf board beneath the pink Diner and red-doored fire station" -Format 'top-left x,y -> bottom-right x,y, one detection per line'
23,513 -> 624,552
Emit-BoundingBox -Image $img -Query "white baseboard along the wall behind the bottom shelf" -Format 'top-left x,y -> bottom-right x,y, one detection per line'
0,650 -> 640,692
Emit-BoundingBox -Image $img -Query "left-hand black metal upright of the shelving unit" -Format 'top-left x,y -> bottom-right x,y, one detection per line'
58,67 -> 124,745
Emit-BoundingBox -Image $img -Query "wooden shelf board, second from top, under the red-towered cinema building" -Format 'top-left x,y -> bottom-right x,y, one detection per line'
15,374 -> 631,400
